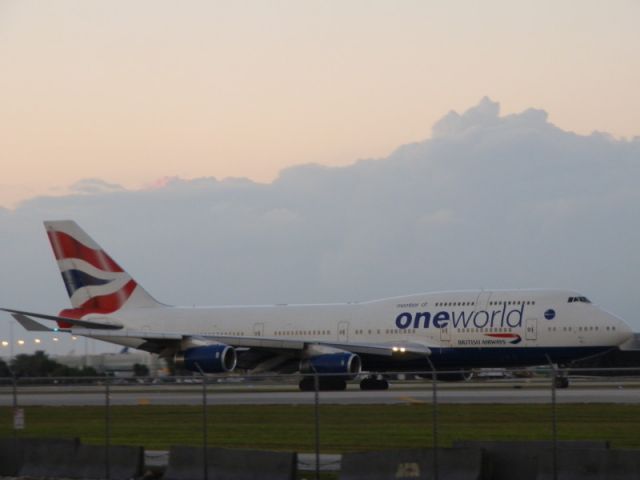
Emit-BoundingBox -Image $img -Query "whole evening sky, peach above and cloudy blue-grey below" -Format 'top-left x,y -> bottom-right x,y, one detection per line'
0,0 -> 640,354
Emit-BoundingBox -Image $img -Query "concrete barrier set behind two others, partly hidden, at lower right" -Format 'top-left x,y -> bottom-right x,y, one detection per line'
453,440 -> 609,480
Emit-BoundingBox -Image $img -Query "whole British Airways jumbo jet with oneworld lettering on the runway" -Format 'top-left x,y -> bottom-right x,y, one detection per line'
2,220 -> 633,391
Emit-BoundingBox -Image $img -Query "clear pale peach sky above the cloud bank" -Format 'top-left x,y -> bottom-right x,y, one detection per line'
0,0 -> 640,206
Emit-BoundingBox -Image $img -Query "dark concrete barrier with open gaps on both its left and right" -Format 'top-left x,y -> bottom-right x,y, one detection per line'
164,446 -> 297,480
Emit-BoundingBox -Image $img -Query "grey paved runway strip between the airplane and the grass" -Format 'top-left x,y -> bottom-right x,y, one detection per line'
0,380 -> 640,407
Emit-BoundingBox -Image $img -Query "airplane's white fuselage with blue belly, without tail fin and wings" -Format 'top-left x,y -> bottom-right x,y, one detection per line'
94,290 -> 632,368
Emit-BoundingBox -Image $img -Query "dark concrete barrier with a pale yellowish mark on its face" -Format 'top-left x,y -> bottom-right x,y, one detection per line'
340,448 -> 480,480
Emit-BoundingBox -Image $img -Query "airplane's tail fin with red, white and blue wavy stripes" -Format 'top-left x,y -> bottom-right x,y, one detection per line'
44,220 -> 160,318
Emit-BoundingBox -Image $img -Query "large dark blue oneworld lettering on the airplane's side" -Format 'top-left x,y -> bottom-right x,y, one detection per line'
396,305 -> 525,329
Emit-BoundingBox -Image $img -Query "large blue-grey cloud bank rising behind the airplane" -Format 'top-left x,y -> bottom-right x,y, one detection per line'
0,98 -> 640,352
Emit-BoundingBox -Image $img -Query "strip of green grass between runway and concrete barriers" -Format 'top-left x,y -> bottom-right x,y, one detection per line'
0,404 -> 640,453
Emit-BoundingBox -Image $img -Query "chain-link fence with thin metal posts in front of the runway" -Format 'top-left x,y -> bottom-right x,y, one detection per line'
0,367 -> 640,478
